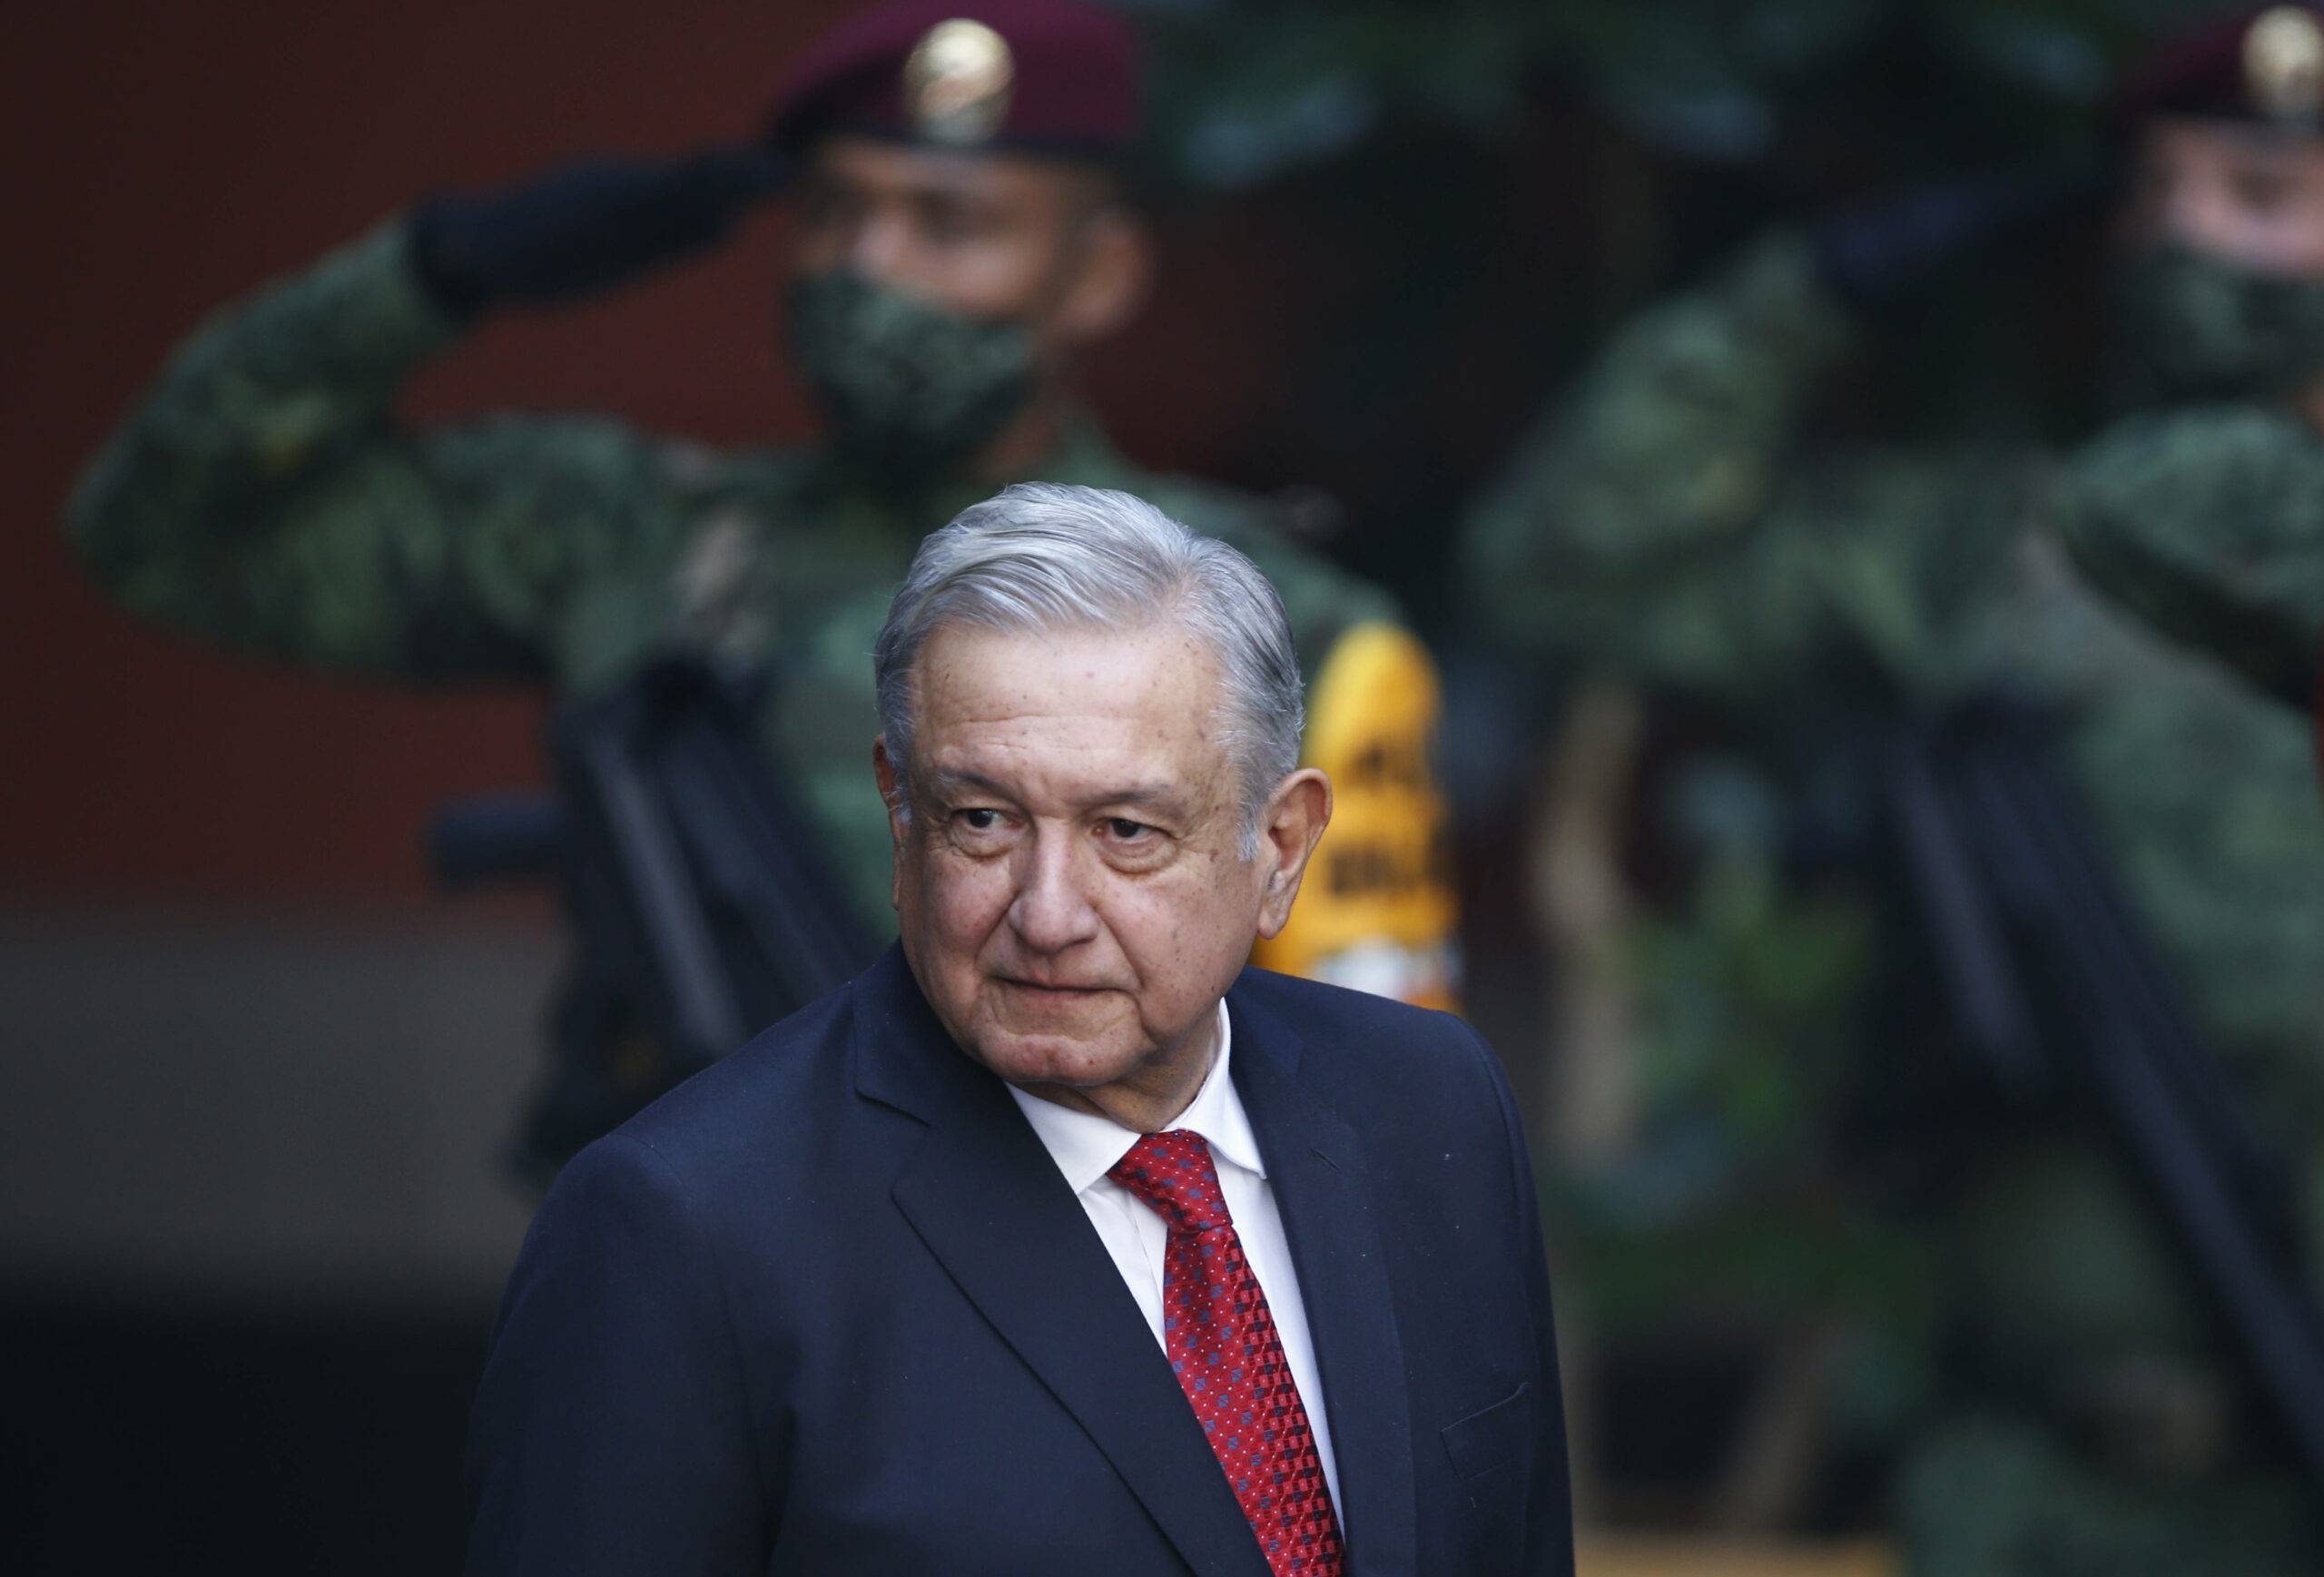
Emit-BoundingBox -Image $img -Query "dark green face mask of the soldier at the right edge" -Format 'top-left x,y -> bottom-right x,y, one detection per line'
2112,244 -> 2324,404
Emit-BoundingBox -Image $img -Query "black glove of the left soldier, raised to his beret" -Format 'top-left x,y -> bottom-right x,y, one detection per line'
411,146 -> 783,313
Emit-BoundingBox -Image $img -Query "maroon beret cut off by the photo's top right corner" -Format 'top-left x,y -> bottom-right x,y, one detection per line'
2112,3 -> 2324,133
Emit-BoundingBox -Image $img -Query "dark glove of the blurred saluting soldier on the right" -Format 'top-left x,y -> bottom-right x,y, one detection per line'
1808,163 -> 2115,311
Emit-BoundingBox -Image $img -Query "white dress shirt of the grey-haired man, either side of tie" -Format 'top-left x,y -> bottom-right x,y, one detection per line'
1009,1001 -> 1339,1510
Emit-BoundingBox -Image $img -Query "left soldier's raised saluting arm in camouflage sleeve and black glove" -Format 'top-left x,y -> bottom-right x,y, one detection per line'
67,151 -> 773,675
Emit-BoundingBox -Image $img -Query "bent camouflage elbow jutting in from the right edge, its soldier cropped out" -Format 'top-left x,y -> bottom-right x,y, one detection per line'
2057,407 -> 2324,711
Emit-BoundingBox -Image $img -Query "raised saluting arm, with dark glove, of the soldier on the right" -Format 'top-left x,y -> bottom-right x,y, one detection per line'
1464,167 -> 2094,687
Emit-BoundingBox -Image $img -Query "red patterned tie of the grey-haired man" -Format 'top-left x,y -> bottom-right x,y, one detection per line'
1107,1129 -> 1341,1577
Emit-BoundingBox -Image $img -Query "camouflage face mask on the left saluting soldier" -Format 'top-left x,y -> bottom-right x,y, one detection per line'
790,270 -> 1034,478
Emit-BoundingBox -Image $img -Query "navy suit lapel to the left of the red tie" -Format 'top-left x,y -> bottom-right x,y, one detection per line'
855,950 -> 1266,1577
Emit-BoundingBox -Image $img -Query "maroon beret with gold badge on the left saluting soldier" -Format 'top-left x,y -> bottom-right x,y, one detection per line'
767,0 -> 1141,158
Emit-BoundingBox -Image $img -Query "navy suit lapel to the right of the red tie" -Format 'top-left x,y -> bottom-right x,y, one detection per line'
1227,991 -> 1418,1577
